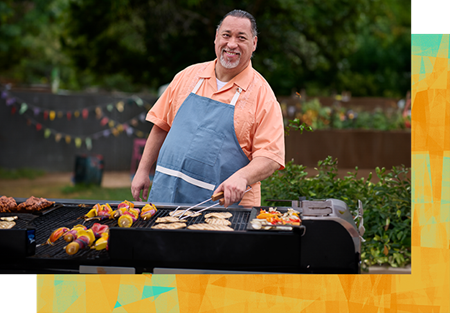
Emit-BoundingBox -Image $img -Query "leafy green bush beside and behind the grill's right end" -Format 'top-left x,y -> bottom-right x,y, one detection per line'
261,156 -> 411,271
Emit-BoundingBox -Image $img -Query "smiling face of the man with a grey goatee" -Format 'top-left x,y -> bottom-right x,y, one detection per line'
214,16 -> 258,74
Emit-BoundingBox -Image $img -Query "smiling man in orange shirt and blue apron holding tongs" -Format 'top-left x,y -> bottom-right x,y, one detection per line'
131,10 -> 284,207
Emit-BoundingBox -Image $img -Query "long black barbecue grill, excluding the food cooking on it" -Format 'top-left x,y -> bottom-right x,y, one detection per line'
0,199 -> 362,274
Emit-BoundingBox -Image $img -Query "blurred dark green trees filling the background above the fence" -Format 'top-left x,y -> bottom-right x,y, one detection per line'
0,0 -> 412,98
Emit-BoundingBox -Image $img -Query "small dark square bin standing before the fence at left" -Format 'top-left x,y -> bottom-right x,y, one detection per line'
74,155 -> 104,186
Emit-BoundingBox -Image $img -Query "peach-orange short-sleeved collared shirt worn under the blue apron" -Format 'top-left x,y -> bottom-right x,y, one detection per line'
147,59 -> 285,206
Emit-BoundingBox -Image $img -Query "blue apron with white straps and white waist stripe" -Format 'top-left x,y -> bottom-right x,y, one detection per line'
148,79 -> 250,203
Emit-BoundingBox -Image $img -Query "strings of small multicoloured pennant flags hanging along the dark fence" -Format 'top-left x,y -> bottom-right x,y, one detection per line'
1,86 -> 150,150
